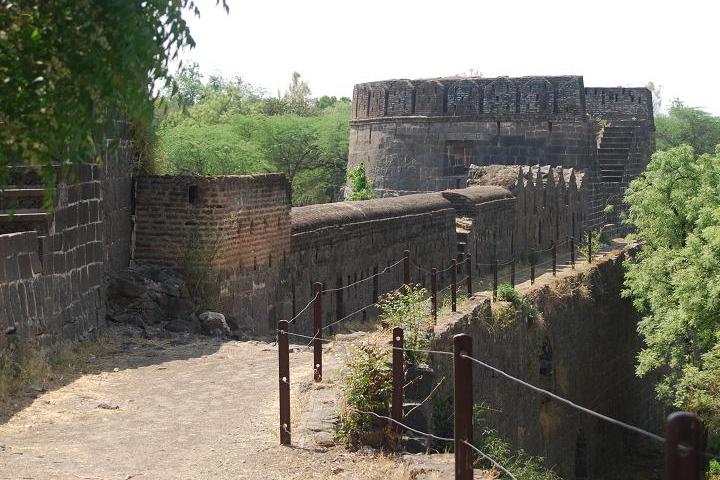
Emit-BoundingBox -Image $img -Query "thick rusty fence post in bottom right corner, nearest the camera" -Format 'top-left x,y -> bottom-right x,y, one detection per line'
664,412 -> 705,480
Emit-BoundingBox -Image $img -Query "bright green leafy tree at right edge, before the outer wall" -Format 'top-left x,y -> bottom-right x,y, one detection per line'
623,145 -> 720,434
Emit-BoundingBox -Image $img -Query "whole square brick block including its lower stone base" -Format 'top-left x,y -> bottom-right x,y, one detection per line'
134,174 -> 290,335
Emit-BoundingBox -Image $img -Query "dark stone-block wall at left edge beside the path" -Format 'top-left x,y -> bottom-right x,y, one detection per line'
0,121 -> 133,354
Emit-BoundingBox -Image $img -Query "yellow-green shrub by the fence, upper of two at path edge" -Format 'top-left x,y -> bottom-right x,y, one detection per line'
378,285 -> 433,366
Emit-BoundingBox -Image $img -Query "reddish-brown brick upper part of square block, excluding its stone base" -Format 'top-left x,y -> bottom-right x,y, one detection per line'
135,174 -> 290,270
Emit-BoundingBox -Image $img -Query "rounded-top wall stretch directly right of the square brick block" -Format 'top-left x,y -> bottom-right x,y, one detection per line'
286,193 -> 457,333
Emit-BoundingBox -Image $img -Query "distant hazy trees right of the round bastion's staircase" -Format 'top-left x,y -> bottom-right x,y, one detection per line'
655,100 -> 720,154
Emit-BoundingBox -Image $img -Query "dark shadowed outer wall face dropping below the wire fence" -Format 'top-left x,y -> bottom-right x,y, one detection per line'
430,248 -> 662,479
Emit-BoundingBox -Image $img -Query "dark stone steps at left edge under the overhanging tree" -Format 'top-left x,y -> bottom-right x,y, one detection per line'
0,167 -> 50,235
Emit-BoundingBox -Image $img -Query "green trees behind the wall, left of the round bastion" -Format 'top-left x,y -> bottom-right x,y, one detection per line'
156,65 -> 350,205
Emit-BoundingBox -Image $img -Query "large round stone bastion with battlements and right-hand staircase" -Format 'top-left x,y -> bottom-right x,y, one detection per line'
348,76 -> 654,236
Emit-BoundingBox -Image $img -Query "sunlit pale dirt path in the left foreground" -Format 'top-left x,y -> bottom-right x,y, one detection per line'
0,332 -> 401,480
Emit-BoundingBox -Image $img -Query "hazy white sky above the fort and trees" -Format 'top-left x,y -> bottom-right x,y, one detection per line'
184,0 -> 720,115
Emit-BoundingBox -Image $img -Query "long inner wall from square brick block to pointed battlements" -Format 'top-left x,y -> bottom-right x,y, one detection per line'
126,166 -> 584,335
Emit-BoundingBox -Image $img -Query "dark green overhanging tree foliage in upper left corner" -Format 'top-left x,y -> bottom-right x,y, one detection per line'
0,0 -> 227,193
